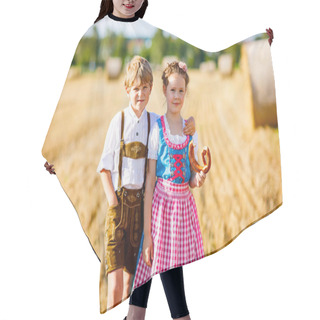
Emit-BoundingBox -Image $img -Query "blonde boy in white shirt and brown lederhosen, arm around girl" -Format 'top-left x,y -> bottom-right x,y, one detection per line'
97,56 -> 195,309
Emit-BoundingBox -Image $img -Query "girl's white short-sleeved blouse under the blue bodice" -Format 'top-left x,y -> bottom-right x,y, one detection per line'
148,115 -> 198,161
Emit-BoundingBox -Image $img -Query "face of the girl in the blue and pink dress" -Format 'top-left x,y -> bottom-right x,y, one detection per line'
163,73 -> 186,114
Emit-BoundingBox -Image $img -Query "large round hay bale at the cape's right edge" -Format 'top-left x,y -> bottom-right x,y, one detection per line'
241,39 -> 278,127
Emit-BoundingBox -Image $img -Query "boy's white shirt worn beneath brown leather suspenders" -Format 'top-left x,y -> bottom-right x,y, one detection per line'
97,106 -> 160,190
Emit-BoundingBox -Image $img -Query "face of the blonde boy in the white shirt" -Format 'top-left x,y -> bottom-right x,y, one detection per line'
126,83 -> 152,113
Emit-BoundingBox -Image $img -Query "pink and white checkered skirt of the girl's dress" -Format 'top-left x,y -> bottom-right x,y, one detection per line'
133,178 -> 204,289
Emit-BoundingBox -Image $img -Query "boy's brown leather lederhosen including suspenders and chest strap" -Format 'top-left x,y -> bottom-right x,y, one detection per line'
106,111 -> 150,274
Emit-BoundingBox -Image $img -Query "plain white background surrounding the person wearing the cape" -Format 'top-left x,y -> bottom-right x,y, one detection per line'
0,0 -> 320,320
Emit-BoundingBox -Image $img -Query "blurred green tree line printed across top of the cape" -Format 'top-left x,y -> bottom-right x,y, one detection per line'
72,26 -> 264,71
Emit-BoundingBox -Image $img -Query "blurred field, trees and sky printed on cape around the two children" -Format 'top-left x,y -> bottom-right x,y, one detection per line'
42,16 -> 282,313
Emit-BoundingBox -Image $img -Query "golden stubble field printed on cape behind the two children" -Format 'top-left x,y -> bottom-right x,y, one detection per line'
43,69 -> 282,259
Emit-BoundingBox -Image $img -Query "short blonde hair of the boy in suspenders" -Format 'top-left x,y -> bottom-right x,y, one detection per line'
124,56 -> 153,88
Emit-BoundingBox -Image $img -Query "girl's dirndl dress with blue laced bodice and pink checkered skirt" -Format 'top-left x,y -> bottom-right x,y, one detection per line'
133,116 -> 204,289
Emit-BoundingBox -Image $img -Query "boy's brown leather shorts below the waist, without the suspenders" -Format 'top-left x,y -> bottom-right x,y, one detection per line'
106,187 -> 143,274
